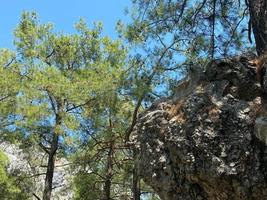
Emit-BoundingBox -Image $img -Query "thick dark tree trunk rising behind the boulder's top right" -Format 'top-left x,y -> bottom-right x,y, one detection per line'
248,0 -> 267,55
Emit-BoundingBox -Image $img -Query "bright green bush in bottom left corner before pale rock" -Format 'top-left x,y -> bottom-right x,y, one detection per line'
0,151 -> 28,200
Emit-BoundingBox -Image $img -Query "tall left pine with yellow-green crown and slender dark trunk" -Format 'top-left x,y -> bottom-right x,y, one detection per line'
15,12 -> 126,200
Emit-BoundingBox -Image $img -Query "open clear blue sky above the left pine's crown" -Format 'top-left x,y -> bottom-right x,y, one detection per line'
0,0 -> 131,48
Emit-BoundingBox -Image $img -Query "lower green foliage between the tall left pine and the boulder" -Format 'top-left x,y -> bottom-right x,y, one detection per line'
73,96 -> 132,200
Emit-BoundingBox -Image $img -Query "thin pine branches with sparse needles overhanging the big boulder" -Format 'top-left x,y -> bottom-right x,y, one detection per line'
117,0 -> 256,97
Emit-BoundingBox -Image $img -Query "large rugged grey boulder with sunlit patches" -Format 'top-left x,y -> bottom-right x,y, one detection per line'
131,55 -> 267,200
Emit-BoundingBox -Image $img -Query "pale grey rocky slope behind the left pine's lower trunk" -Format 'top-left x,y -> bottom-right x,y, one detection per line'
0,142 -> 73,200
